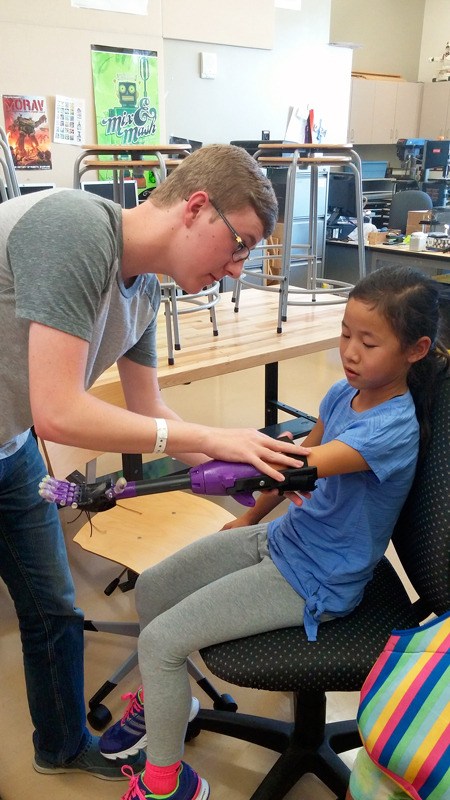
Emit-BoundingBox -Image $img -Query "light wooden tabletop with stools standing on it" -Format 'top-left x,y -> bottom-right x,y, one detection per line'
90,289 -> 344,405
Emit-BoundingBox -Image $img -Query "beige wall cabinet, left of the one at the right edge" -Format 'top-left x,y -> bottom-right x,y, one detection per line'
348,78 -> 423,144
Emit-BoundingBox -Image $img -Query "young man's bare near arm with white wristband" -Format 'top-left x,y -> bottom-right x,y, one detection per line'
28,322 -> 310,480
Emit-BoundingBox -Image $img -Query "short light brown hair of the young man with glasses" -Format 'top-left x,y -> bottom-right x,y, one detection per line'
150,144 -> 278,238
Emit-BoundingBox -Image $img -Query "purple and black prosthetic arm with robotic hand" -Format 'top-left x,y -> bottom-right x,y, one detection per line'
39,456 -> 317,512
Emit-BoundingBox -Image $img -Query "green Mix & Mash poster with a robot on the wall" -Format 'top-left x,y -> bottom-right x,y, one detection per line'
91,45 -> 160,199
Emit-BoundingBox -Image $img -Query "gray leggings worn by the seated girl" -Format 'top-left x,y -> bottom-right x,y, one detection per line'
136,523 -> 304,766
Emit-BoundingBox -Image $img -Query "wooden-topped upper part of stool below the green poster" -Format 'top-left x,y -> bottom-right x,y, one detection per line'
73,144 -> 191,197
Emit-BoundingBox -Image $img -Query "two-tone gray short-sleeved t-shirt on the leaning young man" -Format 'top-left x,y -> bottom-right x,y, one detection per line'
0,189 -> 160,448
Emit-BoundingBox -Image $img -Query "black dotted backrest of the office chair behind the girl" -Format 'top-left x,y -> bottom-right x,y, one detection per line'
392,375 -> 450,618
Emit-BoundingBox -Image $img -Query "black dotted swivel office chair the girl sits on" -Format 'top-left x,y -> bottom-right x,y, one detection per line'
189,376 -> 450,800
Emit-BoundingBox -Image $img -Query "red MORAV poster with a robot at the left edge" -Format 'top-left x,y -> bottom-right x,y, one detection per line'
2,94 -> 52,169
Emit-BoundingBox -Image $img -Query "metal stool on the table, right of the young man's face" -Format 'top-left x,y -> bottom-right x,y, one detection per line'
234,143 -> 365,333
